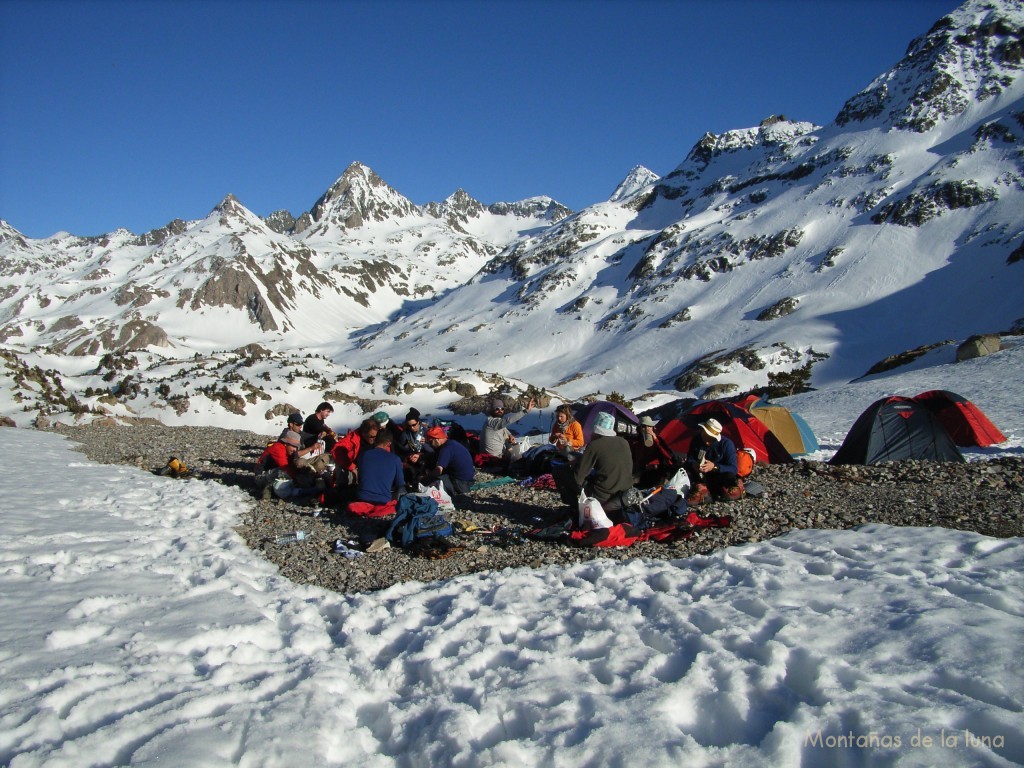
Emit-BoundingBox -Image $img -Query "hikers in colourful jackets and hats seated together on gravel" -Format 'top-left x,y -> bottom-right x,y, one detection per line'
256,399 -> 743,520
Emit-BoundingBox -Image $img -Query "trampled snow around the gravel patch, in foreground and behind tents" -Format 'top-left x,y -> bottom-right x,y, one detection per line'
0,348 -> 1024,768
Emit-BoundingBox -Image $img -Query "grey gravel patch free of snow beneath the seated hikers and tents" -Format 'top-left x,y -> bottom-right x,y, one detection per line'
54,425 -> 1024,593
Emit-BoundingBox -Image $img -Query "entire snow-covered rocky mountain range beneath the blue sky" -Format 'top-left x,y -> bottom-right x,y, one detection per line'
0,0 -> 1024,434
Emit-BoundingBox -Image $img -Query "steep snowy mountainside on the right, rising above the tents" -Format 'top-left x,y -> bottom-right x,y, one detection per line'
346,2 -> 1024,403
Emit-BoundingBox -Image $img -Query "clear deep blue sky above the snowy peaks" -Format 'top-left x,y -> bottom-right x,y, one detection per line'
0,0 -> 958,238
